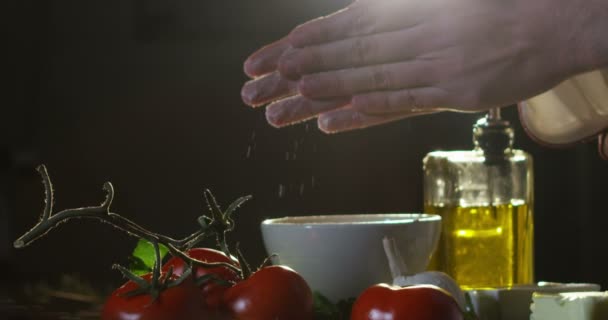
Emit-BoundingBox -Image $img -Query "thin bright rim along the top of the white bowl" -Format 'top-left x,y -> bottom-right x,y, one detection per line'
261,213 -> 441,227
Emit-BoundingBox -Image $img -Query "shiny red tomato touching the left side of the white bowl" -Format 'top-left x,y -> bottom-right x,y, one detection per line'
224,266 -> 313,320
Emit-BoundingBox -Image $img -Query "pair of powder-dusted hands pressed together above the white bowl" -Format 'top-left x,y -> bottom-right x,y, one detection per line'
243,0 -> 604,132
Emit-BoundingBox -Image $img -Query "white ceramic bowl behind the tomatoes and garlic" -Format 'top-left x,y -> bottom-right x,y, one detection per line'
261,213 -> 441,302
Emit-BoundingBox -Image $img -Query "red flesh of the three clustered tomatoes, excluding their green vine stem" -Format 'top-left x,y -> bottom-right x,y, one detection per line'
102,248 -> 313,320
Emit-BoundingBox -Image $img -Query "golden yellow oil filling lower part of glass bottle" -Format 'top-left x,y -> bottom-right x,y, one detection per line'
425,201 -> 534,289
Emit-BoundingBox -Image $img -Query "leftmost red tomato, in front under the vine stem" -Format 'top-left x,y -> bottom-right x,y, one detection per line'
101,274 -> 213,320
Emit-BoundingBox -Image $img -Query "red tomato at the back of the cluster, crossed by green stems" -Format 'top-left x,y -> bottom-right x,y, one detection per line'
162,248 -> 241,309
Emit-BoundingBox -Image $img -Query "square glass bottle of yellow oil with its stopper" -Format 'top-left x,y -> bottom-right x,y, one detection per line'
423,109 -> 534,289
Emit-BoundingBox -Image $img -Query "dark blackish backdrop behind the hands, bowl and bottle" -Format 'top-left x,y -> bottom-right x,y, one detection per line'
0,0 -> 608,289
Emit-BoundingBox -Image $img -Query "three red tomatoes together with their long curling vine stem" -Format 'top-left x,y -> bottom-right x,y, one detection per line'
14,165 -> 312,320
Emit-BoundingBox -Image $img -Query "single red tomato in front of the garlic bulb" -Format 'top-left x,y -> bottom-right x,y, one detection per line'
350,284 -> 463,320
